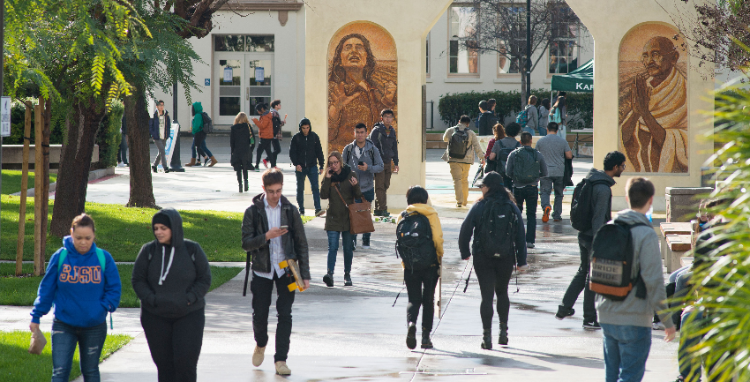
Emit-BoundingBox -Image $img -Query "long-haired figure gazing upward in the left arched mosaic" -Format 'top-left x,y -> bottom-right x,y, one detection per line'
328,33 -> 396,152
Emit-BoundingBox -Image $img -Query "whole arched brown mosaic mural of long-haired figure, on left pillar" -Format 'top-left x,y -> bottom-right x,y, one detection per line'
328,22 -> 398,152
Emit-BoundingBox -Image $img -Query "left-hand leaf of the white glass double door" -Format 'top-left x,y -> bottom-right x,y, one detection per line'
214,54 -> 245,125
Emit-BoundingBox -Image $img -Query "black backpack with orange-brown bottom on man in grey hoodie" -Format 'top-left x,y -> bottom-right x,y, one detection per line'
589,222 -> 648,301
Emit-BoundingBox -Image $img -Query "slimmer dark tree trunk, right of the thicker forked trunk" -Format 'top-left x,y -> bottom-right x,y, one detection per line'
125,87 -> 156,208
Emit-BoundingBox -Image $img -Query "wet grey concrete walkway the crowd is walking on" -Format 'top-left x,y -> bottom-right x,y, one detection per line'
0,138 -> 677,382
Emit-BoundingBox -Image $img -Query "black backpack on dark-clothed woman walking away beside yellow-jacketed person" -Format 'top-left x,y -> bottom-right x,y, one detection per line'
473,200 -> 518,259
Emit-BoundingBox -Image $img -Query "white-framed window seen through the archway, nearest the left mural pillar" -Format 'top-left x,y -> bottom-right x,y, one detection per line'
448,6 -> 479,74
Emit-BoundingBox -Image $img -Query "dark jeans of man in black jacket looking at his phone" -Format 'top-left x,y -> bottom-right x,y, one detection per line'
250,267 -> 294,362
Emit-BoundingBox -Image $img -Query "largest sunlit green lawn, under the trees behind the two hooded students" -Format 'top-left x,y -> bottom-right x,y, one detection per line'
0,195 -> 312,262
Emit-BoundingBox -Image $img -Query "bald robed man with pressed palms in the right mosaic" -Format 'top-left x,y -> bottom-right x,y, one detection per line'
620,36 -> 688,173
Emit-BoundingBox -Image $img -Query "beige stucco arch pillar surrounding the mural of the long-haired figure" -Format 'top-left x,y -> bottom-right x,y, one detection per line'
305,0 -> 451,208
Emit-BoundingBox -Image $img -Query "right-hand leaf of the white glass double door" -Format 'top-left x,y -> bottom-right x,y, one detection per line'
245,53 -> 273,116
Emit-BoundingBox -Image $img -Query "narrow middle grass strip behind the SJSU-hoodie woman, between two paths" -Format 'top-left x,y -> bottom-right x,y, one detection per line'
0,263 -> 244,308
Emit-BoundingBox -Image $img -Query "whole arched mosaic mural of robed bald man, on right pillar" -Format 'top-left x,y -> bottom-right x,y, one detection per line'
619,23 -> 689,173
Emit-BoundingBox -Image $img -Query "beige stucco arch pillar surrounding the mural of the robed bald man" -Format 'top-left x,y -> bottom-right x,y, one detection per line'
567,0 -> 714,211
